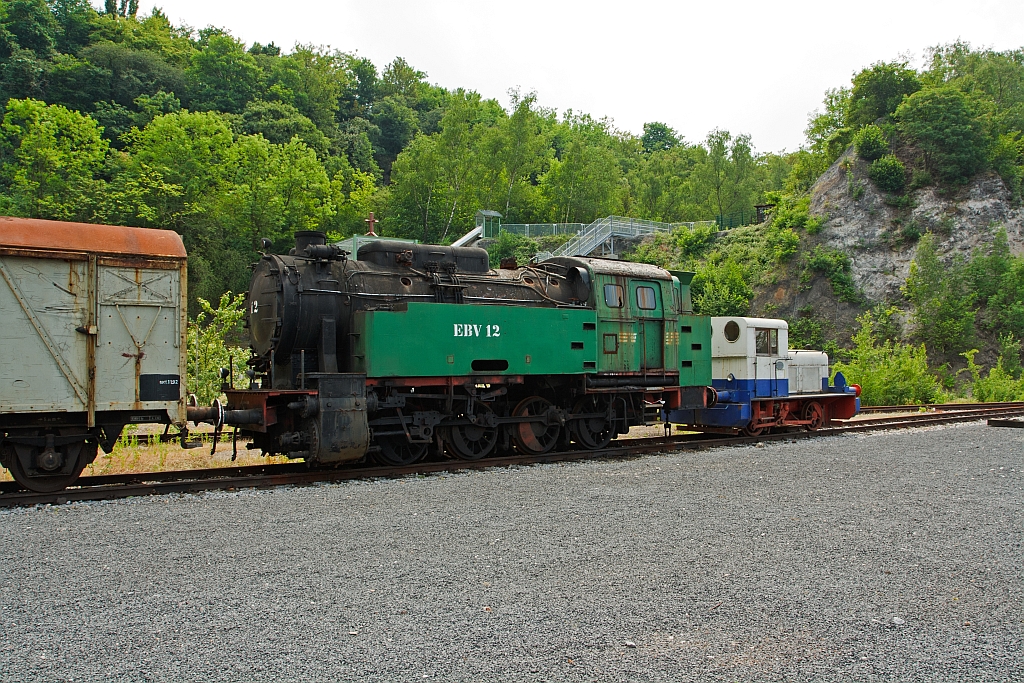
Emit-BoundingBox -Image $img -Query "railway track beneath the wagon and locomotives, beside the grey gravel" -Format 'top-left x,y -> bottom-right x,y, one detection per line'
0,402 -> 1024,508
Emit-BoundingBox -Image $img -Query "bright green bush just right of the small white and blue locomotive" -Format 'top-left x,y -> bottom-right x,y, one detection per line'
833,313 -> 939,405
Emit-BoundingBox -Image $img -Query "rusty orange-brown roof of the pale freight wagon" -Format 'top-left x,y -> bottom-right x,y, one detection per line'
0,216 -> 186,258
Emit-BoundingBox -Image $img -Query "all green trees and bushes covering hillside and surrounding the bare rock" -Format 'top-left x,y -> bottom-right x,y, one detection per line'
0,0 -> 1024,395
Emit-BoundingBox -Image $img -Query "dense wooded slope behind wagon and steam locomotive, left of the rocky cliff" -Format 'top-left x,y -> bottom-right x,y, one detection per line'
0,0 -> 788,314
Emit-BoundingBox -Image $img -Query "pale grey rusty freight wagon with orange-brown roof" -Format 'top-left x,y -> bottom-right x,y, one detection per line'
0,217 -> 186,492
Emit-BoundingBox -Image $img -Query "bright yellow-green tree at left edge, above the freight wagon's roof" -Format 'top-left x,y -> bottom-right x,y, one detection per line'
0,99 -> 108,220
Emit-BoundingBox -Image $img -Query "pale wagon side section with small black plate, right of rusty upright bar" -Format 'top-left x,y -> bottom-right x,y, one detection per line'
96,263 -> 182,411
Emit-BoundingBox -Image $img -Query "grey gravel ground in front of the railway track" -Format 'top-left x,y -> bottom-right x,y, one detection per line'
0,424 -> 1024,681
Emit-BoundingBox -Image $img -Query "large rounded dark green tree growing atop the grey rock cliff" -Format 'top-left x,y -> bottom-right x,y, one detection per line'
896,87 -> 986,182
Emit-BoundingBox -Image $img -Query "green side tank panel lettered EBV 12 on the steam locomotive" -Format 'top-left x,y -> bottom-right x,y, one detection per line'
353,303 -> 598,378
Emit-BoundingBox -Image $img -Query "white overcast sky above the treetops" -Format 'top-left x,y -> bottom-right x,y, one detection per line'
144,0 -> 1024,152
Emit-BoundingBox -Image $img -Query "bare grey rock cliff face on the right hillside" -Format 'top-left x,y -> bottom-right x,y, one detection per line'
811,151 -> 1024,301
